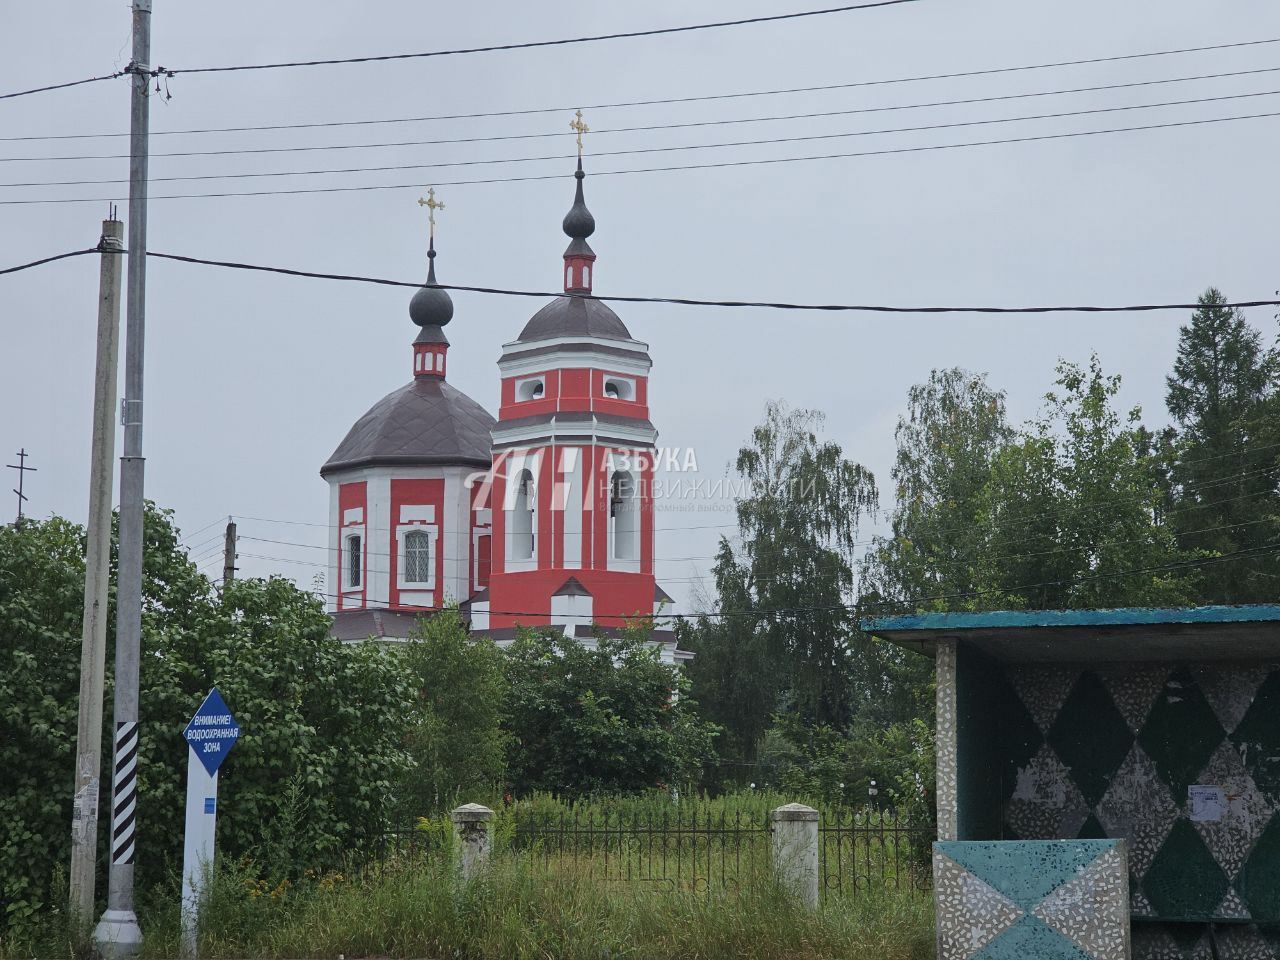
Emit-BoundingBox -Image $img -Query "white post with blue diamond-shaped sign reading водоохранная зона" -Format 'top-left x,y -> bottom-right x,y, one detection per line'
182,687 -> 239,957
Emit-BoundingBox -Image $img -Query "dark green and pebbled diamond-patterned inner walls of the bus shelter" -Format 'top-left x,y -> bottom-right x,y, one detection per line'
940,646 -> 1280,960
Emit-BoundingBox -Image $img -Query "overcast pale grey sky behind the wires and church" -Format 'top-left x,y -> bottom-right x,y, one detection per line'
0,0 -> 1280,609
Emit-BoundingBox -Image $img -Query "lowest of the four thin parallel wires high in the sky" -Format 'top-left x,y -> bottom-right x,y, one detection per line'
10,111 -> 1280,206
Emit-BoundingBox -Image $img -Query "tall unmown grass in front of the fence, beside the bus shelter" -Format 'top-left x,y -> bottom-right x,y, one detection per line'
137,859 -> 933,960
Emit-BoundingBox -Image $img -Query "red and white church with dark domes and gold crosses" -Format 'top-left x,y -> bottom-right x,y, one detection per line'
320,159 -> 690,663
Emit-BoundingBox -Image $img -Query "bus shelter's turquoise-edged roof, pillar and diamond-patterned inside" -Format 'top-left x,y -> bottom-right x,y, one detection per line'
863,605 -> 1280,957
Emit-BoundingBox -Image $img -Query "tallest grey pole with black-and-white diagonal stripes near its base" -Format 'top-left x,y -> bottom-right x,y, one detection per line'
93,0 -> 151,960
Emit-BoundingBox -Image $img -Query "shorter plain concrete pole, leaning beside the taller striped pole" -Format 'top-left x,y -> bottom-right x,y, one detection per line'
69,210 -> 124,942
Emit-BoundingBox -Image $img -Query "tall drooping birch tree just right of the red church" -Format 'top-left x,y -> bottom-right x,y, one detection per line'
681,403 -> 879,782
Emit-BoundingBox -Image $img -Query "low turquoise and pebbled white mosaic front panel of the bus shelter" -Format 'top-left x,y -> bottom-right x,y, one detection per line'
933,840 -> 1129,960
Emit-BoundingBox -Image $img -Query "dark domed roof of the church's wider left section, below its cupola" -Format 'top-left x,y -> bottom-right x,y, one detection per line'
320,376 -> 494,476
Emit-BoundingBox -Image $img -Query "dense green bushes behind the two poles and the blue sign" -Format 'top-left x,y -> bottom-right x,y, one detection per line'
0,507 -> 412,936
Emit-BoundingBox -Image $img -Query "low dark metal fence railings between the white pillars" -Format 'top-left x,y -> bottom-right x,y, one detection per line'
362,804 -> 936,896
